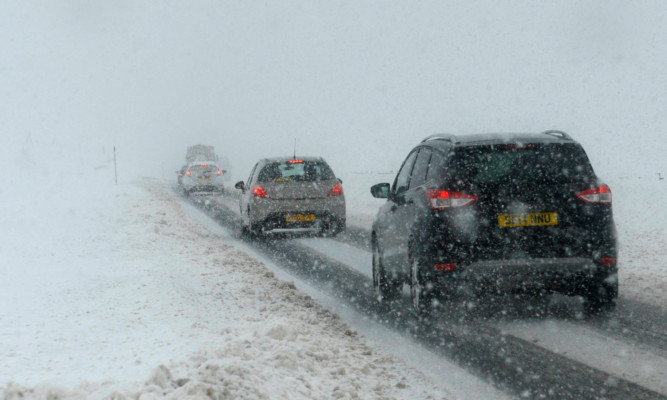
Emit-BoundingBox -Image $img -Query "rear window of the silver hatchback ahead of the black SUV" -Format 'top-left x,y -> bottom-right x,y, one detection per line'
257,161 -> 334,182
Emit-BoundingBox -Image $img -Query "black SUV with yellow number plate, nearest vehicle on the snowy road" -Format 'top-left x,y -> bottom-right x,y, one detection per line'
371,131 -> 618,313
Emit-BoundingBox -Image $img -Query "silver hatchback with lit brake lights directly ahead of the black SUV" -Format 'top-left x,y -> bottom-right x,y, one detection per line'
235,157 -> 345,237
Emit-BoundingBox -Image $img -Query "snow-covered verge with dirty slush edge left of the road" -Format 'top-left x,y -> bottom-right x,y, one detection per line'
0,176 -> 443,400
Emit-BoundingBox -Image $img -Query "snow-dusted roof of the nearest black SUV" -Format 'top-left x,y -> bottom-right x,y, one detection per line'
422,130 -> 575,147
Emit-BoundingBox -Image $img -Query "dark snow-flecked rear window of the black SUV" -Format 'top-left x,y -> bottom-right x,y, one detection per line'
448,143 -> 594,185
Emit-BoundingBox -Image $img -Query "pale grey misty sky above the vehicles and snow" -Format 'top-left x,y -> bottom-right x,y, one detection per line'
0,0 -> 667,183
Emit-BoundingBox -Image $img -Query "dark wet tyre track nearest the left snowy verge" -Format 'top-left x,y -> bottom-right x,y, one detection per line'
188,192 -> 667,399
